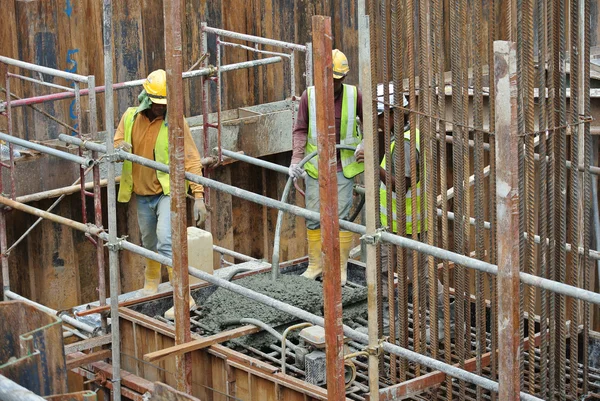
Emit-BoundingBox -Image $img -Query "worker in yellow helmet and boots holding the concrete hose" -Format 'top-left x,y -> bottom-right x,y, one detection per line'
289,49 -> 364,285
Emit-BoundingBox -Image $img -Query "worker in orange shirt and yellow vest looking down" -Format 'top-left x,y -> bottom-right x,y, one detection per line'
114,70 -> 207,319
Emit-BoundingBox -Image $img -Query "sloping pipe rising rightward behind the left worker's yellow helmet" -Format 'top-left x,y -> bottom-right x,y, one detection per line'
0,56 -> 282,109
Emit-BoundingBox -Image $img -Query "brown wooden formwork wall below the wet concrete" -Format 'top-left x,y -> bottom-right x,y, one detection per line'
120,308 -> 327,401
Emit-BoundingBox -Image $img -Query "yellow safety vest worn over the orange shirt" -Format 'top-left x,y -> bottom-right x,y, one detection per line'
117,107 -> 171,203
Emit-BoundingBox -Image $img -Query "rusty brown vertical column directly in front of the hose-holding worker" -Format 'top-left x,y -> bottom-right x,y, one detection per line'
312,15 -> 346,401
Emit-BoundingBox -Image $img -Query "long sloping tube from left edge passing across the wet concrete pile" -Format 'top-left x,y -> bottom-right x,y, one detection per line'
0,196 -> 541,401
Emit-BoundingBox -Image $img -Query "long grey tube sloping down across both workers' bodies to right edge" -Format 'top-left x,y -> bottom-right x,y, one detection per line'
59,135 -> 600,305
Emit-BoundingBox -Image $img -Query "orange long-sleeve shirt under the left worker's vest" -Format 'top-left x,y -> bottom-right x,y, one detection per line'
114,112 -> 204,198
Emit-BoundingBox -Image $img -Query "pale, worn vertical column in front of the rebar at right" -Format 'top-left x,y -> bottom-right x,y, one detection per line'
494,41 -> 520,401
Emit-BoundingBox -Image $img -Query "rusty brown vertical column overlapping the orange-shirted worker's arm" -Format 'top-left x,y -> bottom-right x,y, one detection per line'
164,0 -> 192,394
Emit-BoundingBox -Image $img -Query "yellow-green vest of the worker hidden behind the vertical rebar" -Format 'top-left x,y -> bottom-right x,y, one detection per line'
379,129 -> 427,234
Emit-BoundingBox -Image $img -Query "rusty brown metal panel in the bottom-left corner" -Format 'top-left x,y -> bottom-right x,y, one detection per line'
0,301 -> 67,395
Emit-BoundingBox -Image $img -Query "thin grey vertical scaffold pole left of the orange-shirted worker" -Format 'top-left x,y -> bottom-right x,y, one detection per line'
102,0 -> 121,401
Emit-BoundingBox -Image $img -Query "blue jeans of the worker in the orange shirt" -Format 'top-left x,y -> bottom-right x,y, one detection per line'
136,194 -> 173,258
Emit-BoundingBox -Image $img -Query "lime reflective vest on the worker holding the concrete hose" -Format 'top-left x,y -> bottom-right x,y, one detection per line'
304,84 -> 365,179
